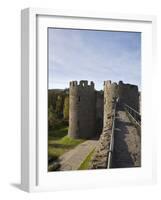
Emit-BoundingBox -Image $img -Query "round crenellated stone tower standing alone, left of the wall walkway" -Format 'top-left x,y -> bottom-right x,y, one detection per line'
68,81 -> 96,139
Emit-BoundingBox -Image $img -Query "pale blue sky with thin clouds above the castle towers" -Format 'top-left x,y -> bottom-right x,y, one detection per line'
48,28 -> 141,90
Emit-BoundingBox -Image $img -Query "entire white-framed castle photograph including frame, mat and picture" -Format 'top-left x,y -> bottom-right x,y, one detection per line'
21,8 -> 156,192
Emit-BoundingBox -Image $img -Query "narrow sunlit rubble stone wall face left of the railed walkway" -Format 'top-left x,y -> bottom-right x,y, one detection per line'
91,81 -> 118,169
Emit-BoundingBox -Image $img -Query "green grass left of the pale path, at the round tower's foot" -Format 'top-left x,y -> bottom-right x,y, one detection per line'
48,126 -> 84,160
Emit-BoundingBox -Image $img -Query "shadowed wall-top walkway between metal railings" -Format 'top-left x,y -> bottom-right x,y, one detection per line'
113,110 -> 141,168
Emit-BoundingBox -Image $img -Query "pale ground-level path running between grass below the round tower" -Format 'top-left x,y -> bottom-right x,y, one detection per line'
59,140 -> 98,171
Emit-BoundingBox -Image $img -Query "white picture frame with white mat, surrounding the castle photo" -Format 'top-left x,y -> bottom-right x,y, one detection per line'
21,8 -> 156,192
